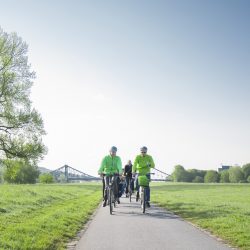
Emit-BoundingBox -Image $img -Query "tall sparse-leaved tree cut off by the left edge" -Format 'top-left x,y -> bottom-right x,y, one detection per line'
0,28 -> 46,164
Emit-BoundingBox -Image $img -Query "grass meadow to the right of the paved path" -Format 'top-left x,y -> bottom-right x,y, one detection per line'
151,183 -> 250,249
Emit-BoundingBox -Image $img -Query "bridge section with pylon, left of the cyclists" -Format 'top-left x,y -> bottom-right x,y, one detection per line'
50,165 -> 101,182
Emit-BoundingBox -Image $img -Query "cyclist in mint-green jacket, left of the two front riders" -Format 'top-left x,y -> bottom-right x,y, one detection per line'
98,146 -> 122,207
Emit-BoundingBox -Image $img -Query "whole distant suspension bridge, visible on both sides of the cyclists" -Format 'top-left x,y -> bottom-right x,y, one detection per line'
50,165 -> 171,182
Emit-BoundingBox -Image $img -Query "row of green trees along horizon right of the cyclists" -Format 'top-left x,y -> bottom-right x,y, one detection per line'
171,163 -> 250,183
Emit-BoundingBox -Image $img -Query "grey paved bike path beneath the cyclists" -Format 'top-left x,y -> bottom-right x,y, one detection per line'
76,198 -> 231,250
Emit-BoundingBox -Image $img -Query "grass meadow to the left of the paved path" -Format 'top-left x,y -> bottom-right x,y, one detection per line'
0,183 -> 101,249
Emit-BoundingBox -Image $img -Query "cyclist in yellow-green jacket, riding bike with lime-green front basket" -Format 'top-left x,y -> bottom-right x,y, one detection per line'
132,146 -> 155,207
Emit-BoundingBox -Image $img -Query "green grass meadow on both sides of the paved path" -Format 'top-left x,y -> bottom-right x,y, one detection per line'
0,183 -> 250,250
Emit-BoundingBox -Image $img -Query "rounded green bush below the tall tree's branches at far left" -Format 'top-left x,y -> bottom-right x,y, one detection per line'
4,159 -> 39,184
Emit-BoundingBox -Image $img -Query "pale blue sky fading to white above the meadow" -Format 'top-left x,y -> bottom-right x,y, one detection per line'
0,0 -> 250,176
